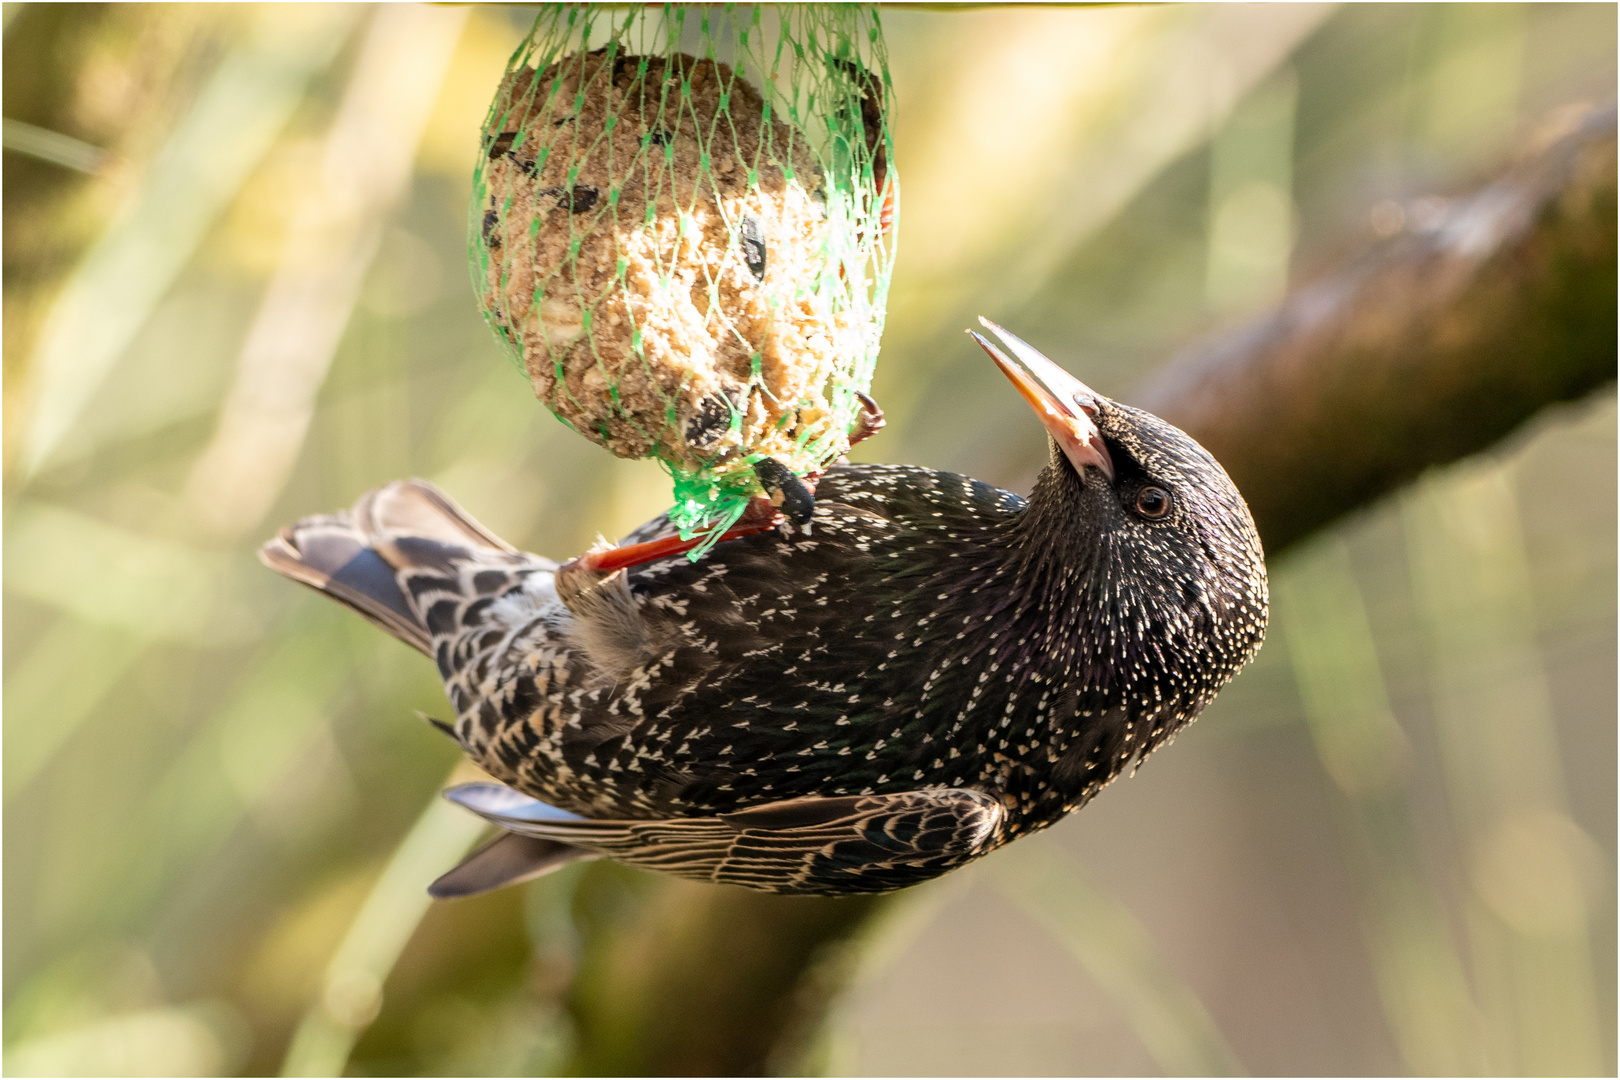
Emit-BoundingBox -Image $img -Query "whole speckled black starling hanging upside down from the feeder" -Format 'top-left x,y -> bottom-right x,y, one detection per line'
261,322 -> 1267,897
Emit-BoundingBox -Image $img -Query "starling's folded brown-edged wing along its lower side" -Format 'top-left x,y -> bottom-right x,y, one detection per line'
446,784 -> 1004,894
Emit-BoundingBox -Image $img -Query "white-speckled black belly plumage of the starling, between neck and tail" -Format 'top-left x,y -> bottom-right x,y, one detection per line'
449,466 -> 1075,816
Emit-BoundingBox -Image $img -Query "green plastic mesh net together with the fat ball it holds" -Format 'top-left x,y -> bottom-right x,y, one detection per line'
468,3 -> 897,557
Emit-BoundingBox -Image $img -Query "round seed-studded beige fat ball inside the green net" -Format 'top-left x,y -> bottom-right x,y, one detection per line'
481,50 -> 860,470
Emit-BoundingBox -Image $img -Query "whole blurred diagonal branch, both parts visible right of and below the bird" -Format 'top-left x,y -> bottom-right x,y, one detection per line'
572,107 -> 1617,1075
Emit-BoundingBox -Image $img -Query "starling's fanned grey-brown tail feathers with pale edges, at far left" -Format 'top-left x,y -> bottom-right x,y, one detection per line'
259,479 -> 517,656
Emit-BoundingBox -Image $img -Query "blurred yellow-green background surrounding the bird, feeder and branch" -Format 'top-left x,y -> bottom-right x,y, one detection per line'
3,3 -> 1617,1075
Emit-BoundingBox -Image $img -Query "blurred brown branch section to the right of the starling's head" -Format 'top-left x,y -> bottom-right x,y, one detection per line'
1132,107 -> 1615,554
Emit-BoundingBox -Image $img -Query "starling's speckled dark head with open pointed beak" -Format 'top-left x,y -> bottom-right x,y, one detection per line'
974,321 -> 1267,719
